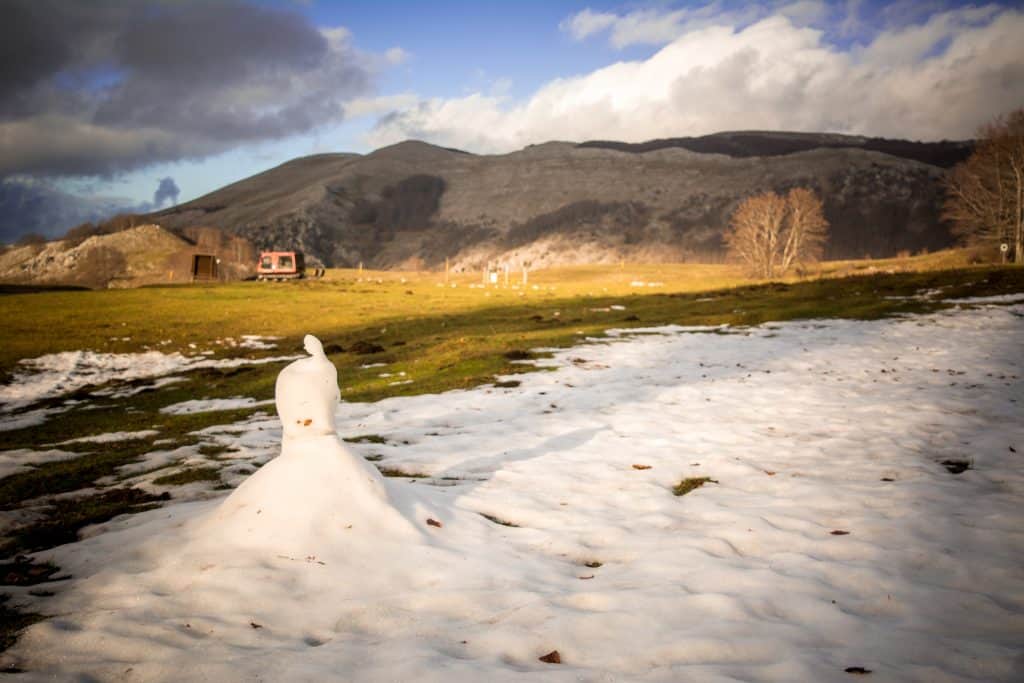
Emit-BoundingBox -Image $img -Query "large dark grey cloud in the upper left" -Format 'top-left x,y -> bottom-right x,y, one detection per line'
0,0 -> 372,177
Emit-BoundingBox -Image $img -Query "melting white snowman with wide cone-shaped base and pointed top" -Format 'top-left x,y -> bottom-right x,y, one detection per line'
197,335 -> 422,555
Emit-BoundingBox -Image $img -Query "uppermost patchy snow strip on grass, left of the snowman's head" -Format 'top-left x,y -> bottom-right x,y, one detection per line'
0,351 -> 298,421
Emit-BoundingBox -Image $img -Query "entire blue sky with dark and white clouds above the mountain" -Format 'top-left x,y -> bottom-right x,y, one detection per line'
0,0 -> 1024,242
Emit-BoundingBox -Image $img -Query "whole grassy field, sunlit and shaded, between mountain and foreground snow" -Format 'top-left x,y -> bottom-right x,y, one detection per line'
0,252 -> 1024,555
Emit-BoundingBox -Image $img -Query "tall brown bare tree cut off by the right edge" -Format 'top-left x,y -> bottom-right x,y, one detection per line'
942,109 -> 1024,263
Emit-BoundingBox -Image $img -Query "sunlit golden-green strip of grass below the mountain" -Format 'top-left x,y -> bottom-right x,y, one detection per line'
0,246 -> 991,374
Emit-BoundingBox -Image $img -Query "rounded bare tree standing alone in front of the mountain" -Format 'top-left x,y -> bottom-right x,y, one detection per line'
725,187 -> 828,278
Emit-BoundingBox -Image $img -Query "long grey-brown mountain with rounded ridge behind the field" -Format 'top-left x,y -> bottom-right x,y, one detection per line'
148,131 -> 971,269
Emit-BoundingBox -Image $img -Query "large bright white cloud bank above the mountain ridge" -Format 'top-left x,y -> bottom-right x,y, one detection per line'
368,8 -> 1024,152
